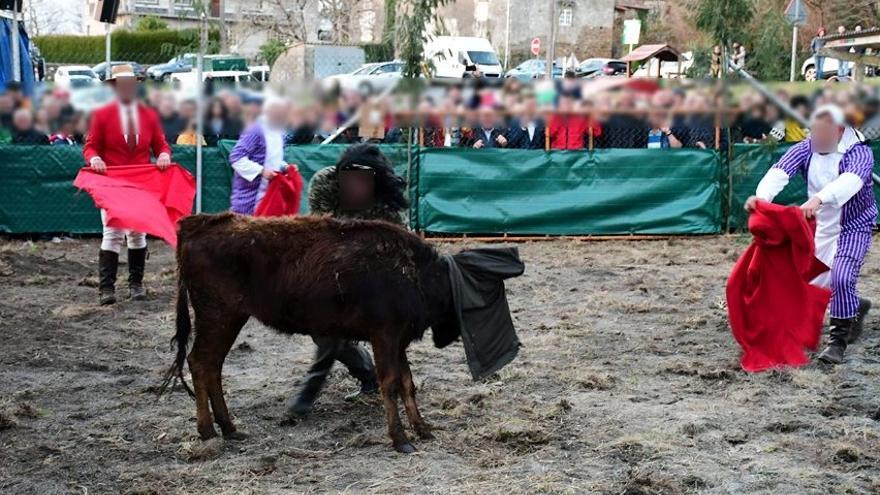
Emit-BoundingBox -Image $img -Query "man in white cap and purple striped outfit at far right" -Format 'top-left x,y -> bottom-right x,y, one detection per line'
745,105 -> 877,364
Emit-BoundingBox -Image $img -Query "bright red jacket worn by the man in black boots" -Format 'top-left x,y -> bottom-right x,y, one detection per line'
83,101 -> 171,167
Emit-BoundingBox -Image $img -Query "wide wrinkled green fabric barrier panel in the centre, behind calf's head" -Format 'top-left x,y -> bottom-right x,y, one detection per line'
417,148 -> 722,235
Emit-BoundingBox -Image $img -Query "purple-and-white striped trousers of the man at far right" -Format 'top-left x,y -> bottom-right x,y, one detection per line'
831,231 -> 871,319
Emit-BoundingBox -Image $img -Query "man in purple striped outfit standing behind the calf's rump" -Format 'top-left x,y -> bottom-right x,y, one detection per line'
229,96 -> 288,215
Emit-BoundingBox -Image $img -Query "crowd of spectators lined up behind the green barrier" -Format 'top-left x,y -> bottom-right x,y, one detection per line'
0,72 -> 880,150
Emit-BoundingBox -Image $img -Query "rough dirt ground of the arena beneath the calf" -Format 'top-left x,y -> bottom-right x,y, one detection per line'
0,237 -> 880,495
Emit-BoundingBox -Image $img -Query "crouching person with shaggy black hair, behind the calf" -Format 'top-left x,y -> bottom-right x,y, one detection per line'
287,143 -> 409,417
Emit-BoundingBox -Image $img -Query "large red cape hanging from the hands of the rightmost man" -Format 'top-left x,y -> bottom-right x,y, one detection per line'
727,202 -> 831,371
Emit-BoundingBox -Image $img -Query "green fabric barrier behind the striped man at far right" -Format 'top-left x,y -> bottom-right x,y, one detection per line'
727,143 -> 880,232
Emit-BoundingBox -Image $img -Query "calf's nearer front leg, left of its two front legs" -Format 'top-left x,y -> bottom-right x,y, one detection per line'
371,331 -> 416,454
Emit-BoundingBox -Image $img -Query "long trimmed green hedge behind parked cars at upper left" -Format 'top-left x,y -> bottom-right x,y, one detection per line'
34,29 -> 220,65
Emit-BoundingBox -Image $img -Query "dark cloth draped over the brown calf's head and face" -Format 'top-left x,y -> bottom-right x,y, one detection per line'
447,247 -> 525,381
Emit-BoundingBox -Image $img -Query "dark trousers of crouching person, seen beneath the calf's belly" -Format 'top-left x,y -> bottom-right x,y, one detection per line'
302,336 -> 376,397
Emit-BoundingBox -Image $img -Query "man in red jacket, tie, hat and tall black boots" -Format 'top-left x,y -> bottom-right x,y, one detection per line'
83,65 -> 171,305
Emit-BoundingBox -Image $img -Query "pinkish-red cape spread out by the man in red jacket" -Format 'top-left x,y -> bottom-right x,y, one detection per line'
73,164 -> 196,246
